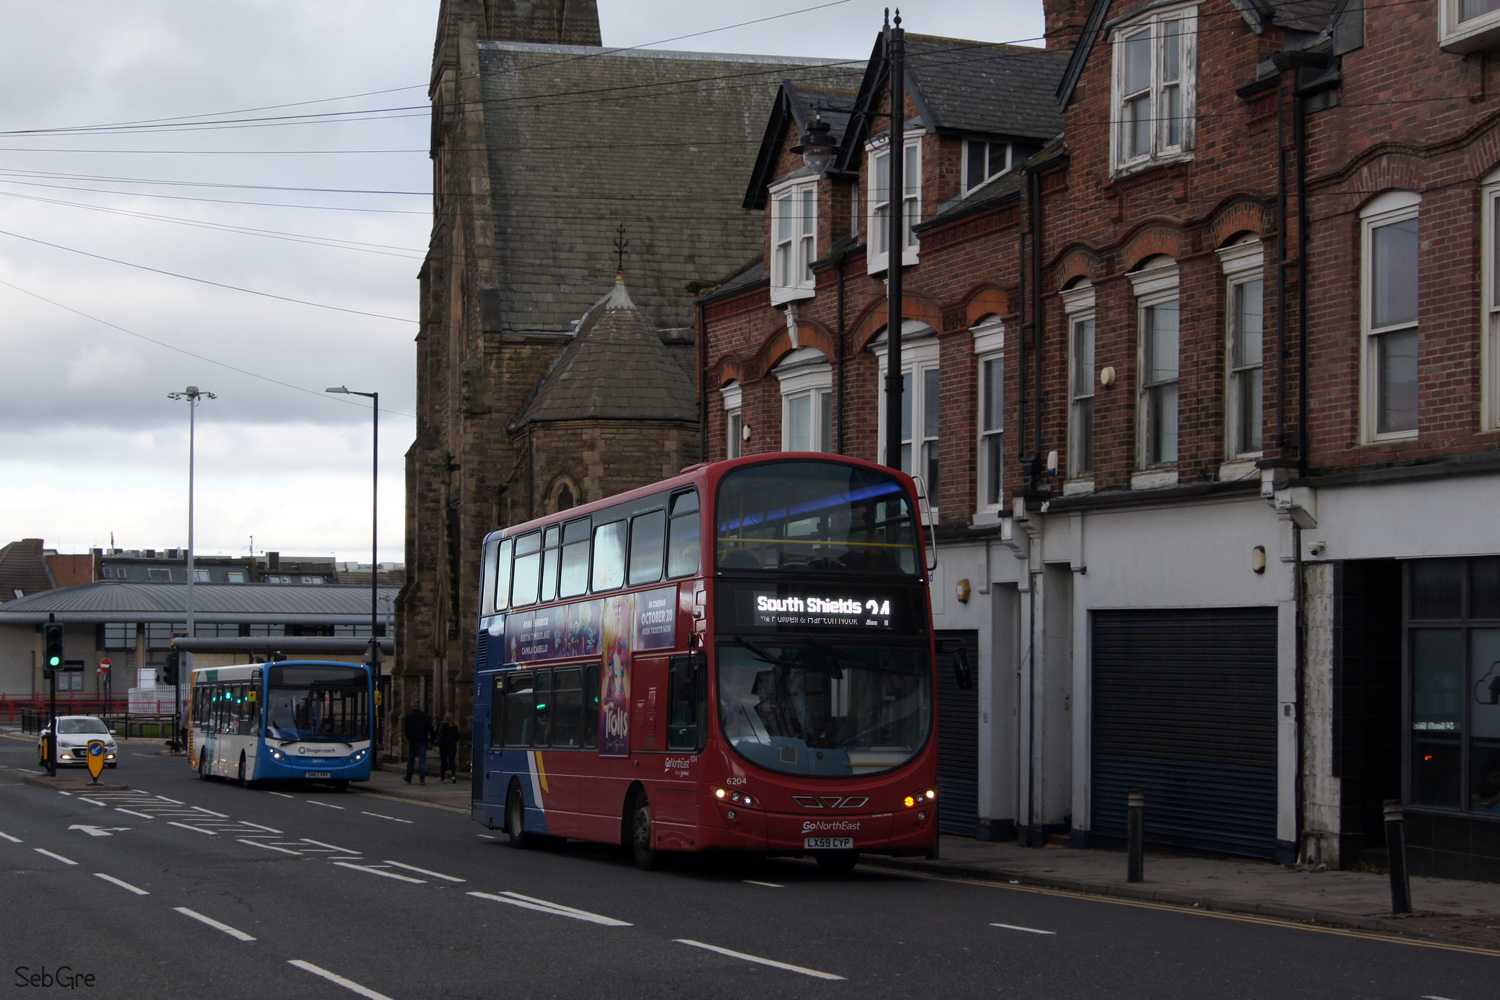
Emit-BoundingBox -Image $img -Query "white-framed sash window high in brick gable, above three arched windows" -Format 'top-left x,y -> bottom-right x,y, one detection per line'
1110,7 -> 1199,172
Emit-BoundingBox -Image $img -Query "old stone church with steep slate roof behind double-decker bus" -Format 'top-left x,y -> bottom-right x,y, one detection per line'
399,0 -> 837,732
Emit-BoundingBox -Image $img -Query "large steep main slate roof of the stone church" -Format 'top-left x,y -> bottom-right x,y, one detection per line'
479,42 -> 843,333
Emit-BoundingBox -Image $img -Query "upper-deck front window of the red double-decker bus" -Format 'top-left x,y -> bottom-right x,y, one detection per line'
714,462 -> 918,576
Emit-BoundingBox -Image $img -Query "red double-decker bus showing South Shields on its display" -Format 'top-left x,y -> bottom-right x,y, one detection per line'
473,453 -> 938,871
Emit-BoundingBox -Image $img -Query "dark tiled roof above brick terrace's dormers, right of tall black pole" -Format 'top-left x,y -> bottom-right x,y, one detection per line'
906,34 -> 1068,139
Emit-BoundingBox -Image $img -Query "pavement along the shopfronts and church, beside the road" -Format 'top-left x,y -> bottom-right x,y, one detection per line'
351,762 -> 1500,952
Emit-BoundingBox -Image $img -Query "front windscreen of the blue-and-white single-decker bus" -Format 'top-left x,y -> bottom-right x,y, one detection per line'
266,664 -> 371,742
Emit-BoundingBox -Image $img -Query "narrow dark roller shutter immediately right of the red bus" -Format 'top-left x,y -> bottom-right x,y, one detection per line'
936,630 -> 980,837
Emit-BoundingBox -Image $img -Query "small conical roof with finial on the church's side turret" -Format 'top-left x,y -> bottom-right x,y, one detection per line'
512,274 -> 698,429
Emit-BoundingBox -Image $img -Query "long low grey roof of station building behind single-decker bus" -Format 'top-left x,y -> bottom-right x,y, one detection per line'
0,580 -> 401,625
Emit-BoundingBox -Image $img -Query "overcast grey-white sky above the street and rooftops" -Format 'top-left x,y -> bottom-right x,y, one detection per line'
0,0 -> 1041,562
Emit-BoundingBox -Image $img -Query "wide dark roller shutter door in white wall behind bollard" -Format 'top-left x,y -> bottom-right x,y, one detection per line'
1091,609 -> 1277,858
